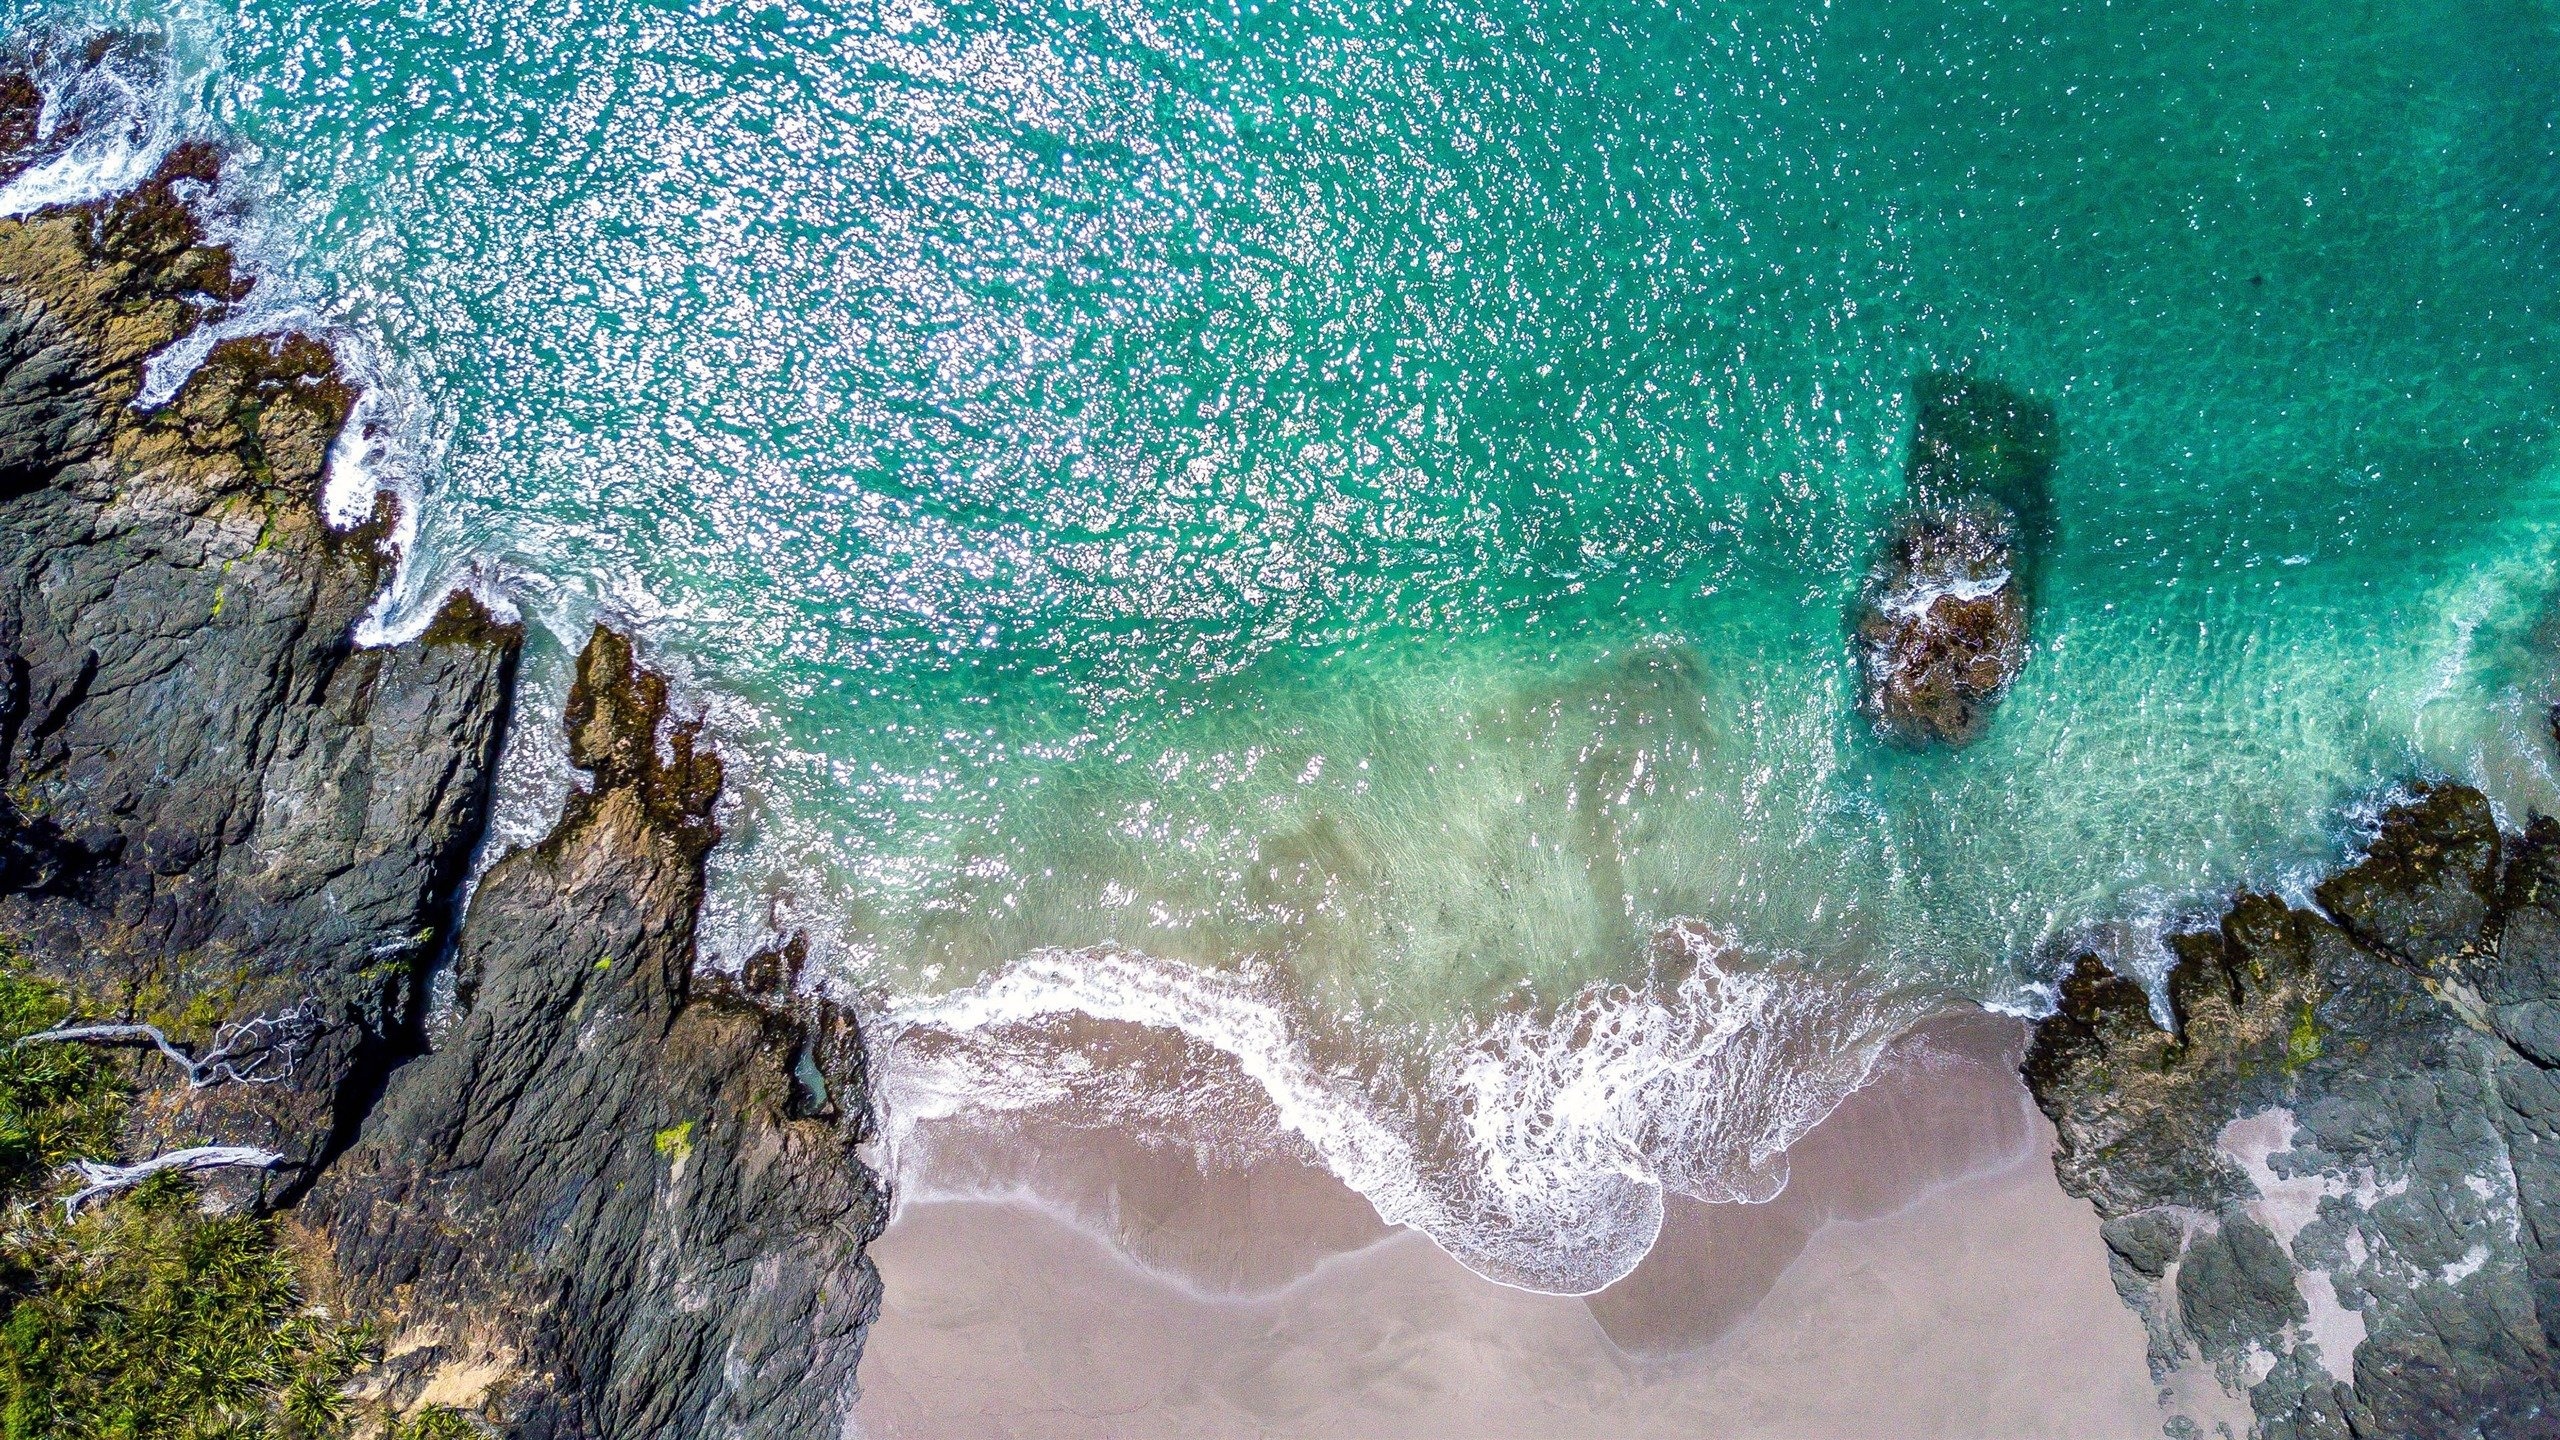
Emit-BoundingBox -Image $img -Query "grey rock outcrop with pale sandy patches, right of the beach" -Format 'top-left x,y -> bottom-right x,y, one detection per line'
2025,784 -> 2560,1440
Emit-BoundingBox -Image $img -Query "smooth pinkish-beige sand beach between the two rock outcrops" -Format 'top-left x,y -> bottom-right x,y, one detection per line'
860,1017 -> 2161,1440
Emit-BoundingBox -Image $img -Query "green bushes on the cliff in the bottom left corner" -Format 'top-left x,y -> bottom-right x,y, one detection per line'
0,948 -> 373,1440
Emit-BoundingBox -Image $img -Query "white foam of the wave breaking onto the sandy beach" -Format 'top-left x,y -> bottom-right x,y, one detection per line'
881,925 -> 1892,1294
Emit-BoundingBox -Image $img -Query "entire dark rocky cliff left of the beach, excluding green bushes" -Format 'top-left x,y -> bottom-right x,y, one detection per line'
0,106 -> 881,1437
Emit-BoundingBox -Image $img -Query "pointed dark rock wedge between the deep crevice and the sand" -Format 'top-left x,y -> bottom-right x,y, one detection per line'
305,630 -> 883,1437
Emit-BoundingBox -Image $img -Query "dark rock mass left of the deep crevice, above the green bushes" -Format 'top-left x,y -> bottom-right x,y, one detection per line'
0,137 -> 520,1194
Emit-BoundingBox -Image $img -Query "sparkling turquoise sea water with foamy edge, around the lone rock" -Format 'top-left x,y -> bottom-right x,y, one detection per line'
10,0 -> 2560,1289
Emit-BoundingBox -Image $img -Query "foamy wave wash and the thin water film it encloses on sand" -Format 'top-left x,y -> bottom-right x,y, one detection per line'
873,922 -> 1925,1294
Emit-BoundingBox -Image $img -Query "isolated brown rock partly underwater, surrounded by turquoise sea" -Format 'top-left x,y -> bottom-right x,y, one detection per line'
1851,374 -> 2053,746
